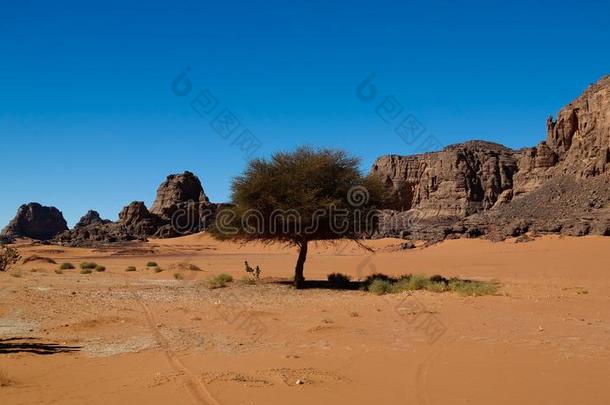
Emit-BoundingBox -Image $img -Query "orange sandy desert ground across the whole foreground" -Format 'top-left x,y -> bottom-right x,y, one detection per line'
0,235 -> 610,405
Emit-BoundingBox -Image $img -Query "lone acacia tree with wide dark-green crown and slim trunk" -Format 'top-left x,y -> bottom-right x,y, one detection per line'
210,147 -> 385,288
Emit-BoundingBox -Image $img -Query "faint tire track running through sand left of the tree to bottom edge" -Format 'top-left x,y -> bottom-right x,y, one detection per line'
133,292 -> 220,405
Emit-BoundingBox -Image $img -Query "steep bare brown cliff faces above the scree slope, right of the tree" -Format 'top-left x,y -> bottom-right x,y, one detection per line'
372,76 -> 610,235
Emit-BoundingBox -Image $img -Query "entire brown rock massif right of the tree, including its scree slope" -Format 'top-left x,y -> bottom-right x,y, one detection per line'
372,76 -> 610,241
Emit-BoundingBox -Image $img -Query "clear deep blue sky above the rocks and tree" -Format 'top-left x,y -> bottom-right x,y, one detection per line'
0,0 -> 610,226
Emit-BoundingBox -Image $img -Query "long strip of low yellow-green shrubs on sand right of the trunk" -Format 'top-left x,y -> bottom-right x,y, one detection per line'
364,274 -> 499,296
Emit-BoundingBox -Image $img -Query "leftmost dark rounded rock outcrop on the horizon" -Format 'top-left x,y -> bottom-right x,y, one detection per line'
2,203 -> 68,240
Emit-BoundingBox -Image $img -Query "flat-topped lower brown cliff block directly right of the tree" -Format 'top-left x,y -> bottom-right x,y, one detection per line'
372,141 -> 518,218
